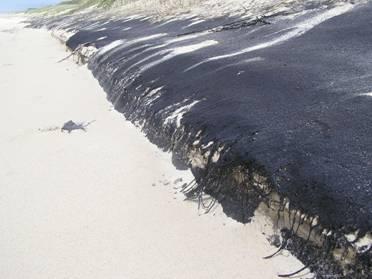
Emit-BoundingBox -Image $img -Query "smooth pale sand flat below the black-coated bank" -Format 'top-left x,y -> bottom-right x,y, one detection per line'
0,17 -> 306,279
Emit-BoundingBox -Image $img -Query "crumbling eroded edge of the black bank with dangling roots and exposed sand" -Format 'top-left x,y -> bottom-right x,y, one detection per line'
59,30 -> 372,279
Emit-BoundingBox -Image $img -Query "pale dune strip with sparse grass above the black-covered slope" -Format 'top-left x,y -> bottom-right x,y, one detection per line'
28,0 -> 354,23
